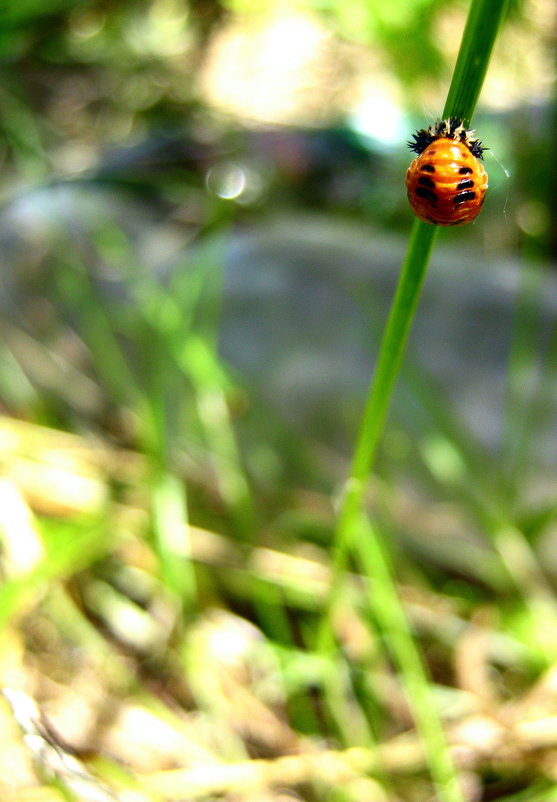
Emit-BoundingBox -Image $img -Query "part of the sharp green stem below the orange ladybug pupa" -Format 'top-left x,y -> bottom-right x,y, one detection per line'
320,221 -> 464,802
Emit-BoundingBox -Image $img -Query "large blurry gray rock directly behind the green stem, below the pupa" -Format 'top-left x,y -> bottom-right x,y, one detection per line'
222,218 -> 557,463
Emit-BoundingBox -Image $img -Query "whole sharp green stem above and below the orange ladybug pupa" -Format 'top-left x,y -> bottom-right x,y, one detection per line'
318,0 -> 507,802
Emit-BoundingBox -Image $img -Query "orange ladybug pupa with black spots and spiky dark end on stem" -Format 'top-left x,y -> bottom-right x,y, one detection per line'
406,118 -> 487,226
